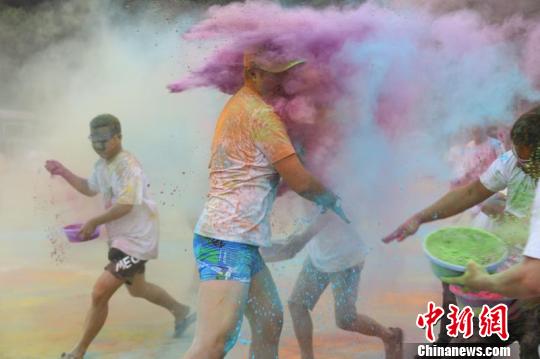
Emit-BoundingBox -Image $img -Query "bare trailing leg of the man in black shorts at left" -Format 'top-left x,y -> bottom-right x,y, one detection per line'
126,273 -> 189,323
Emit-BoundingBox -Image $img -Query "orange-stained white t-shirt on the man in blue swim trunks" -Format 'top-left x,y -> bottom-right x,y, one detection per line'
195,86 -> 295,247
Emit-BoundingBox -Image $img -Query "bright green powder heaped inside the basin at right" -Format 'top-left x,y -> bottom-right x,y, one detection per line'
426,227 -> 505,266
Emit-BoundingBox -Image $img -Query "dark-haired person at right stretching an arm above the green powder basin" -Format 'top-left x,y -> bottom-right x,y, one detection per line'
383,107 -> 540,358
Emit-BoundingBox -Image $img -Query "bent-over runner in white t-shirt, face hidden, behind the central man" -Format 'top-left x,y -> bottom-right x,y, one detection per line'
261,205 -> 403,359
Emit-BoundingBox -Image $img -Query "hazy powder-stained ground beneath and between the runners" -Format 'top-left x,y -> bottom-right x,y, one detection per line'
0,226 -> 520,359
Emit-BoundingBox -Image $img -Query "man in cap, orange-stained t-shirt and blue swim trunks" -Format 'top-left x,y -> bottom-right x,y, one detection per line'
184,52 -> 348,359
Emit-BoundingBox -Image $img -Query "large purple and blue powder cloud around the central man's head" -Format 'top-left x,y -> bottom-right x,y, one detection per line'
169,1 -> 540,191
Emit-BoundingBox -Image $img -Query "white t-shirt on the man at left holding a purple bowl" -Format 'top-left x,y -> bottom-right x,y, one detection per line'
88,151 -> 159,260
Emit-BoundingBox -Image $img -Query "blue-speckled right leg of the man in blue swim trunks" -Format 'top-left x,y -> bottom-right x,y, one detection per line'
246,266 -> 283,359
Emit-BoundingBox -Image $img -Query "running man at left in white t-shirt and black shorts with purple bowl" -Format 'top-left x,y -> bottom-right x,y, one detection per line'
45,114 -> 195,359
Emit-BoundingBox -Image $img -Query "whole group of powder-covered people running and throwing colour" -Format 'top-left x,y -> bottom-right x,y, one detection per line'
46,47 -> 540,359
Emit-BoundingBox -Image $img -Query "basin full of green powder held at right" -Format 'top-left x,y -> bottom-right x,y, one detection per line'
423,227 -> 508,278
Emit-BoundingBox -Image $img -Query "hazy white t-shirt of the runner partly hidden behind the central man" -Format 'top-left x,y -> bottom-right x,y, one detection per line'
306,205 -> 369,273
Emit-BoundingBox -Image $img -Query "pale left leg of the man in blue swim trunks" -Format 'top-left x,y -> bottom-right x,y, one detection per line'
183,280 -> 249,359
